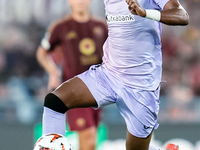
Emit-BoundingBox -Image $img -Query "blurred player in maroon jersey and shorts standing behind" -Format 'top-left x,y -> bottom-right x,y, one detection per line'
36,0 -> 108,150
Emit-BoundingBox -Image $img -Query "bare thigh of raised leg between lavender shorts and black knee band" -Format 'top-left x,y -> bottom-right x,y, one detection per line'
53,77 -> 97,109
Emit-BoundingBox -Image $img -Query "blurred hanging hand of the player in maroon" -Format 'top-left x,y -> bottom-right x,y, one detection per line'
47,75 -> 61,92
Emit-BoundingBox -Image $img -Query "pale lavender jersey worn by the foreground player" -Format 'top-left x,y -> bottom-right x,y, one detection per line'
103,0 -> 169,90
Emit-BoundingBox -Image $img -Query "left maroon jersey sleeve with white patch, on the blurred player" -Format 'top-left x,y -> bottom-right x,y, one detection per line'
41,23 -> 61,51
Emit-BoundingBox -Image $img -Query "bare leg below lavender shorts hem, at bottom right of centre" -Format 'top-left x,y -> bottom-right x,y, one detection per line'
126,132 -> 152,150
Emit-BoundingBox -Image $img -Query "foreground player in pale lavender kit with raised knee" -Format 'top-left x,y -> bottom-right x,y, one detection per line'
43,0 -> 189,150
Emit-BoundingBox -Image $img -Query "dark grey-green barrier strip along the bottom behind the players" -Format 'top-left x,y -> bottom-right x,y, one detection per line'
0,124 -> 200,150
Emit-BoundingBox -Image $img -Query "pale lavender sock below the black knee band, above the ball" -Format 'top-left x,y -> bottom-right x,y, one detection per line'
42,107 -> 66,136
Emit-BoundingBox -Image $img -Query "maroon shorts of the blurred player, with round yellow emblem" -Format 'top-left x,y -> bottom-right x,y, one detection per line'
66,108 -> 101,131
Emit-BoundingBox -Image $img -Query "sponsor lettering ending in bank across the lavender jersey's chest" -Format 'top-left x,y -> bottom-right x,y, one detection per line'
106,13 -> 135,23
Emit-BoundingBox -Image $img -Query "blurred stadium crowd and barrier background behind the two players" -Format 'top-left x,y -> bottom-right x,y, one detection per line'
0,0 -> 200,150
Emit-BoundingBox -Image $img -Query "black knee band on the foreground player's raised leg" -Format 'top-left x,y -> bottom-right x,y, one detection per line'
44,93 -> 68,113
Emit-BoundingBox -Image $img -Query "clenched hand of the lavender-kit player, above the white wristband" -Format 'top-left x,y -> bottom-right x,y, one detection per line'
126,0 -> 146,17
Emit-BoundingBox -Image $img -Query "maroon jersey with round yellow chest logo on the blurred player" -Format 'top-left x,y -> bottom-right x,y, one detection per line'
45,16 -> 108,81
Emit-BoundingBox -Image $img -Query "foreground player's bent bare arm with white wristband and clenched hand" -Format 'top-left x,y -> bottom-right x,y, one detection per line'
126,0 -> 189,25
